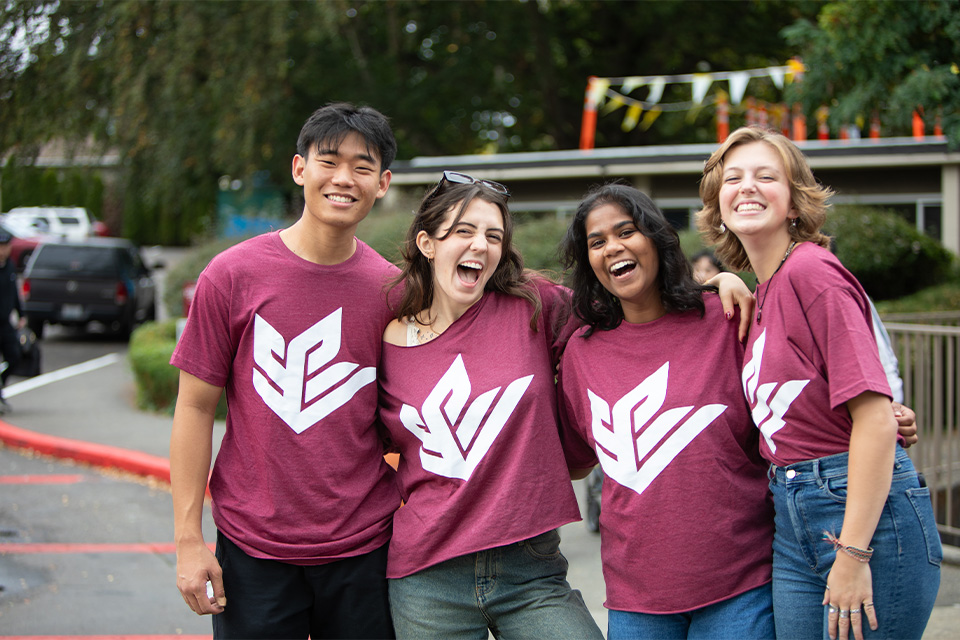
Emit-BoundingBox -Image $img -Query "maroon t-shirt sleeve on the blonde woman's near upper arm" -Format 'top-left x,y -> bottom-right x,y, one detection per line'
806,286 -> 892,409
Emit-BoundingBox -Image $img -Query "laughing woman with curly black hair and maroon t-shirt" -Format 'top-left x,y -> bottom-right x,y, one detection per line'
558,184 -> 774,640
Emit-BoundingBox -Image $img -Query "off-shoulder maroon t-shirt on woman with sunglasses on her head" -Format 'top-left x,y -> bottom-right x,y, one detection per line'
380,282 -> 580,578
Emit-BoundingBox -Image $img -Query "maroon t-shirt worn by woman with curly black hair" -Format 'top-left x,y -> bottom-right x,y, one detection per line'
558,294 -> 773,614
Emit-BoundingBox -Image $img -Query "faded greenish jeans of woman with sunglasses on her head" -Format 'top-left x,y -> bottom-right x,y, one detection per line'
389,530 -> 603,640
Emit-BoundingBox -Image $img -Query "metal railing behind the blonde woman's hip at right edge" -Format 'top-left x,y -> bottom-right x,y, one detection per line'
884,320 -> 960,545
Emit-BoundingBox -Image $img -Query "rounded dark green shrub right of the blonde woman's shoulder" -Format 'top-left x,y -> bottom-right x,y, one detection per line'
824,205 -> 954,300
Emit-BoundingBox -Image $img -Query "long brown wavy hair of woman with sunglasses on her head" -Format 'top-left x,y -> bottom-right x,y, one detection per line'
389,182 -> 543,330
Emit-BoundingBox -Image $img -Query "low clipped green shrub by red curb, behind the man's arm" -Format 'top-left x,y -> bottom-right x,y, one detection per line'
128,320 -> 227,419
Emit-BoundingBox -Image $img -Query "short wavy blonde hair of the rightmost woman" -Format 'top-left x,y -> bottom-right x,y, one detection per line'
696,127 -> 833,271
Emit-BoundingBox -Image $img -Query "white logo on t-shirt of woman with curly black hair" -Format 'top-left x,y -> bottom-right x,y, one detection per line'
587,362 -> 727,494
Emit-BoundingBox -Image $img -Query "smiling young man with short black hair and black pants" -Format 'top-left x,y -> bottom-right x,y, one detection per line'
170,103 -> 400,638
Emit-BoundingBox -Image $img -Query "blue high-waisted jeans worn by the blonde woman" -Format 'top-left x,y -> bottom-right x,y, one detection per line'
770,446 -> 943,640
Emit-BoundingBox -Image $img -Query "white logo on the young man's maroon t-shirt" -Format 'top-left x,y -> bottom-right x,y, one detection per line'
253,308 -> 377,433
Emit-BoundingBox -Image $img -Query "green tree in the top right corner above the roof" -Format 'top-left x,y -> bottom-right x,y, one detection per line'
783,0 -> 960,148
